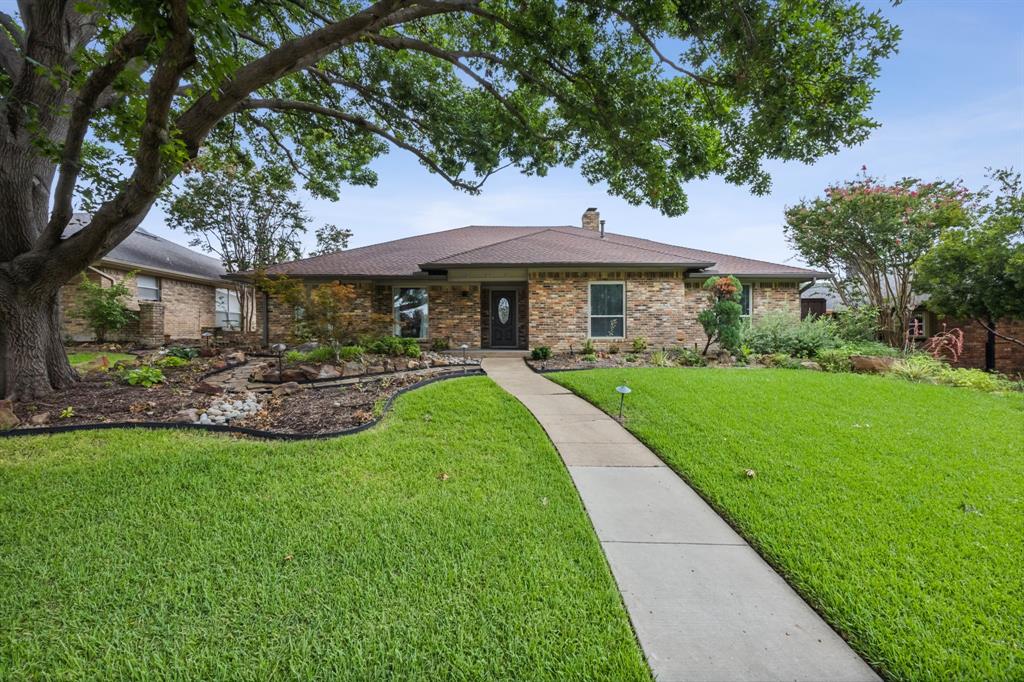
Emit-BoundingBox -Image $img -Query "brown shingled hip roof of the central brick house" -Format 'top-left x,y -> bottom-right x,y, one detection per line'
256,225 -> 822,280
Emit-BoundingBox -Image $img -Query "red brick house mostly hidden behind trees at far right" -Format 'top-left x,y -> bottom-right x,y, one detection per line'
801,282 -> 1024,375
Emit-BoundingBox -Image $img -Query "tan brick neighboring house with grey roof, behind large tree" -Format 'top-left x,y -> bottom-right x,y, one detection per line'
60,214 -> 241,345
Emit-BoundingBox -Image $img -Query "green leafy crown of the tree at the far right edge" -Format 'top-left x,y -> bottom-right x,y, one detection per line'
914,171 -> 1024,344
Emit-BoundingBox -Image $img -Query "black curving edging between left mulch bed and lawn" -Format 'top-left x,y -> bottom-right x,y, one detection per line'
0,368 -> 486,440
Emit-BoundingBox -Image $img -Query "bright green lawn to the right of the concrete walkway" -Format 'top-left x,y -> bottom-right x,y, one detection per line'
551,369 -> 1024,680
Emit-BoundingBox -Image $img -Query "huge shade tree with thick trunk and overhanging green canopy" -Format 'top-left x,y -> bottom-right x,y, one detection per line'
0,0 -> 899,398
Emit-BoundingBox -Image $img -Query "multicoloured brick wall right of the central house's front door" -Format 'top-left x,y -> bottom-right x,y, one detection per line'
528,272 -> 800,351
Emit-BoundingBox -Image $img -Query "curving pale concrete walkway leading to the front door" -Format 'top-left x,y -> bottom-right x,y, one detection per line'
483,358 -> 879,682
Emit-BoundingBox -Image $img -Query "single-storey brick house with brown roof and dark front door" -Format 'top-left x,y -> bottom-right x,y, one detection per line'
243,209 -> 822,351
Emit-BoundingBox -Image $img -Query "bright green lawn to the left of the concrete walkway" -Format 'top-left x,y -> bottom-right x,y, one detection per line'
0,378 -> 649,680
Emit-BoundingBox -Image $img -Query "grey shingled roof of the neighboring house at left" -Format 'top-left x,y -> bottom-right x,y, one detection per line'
63,213 -> 224,281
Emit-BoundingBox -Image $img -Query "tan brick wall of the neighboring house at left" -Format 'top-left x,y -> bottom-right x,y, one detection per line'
58,267 -> 216,341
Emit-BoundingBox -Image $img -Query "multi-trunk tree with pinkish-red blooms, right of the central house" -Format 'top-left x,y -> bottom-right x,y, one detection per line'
784,169 -> 974,345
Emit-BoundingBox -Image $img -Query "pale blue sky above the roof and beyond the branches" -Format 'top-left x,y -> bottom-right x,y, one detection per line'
123,0 -> 1024,264
